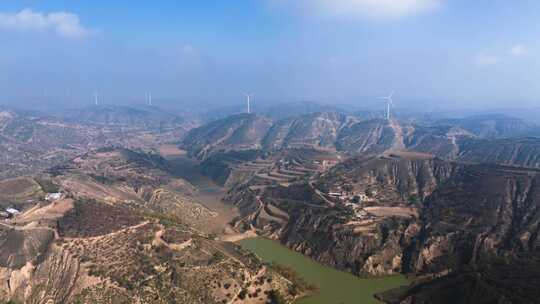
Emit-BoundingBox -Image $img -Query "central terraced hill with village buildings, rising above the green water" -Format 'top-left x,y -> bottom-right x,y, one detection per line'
228,158 -> 456,275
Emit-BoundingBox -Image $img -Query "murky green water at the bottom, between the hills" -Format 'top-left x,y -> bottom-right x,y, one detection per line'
240,238 -> 408,304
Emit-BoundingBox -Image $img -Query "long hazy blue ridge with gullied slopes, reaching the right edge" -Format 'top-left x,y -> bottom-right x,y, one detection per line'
181,112 -> 540,167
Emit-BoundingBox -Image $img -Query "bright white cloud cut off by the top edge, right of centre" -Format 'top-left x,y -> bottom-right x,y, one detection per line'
270,0 -> 443,17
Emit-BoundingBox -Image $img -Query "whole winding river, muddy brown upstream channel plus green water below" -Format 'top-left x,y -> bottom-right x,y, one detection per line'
161,145 -> 408,304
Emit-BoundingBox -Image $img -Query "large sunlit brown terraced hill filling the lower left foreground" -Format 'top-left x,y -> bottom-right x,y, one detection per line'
0,148 -> 296,304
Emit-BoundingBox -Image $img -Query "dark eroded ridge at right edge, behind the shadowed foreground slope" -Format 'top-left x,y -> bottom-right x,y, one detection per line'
404,166 -> 540,273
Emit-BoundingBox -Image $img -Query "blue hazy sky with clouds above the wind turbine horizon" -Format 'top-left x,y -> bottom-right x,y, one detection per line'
0,0 -> 540,109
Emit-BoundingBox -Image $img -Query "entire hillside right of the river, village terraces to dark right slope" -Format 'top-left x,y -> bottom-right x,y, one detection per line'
224,156 -> 540,303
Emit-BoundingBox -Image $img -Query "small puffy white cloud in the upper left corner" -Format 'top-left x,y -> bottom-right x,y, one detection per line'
0,9 -> 92,38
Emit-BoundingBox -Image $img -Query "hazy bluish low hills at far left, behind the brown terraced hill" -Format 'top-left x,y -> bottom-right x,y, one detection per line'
0,107 -> 198,179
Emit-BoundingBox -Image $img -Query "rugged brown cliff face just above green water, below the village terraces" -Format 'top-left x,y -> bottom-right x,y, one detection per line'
279,204 -> 418,275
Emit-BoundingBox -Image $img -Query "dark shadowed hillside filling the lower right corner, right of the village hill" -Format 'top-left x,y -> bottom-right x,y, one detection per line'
386,166 -> 540,303
